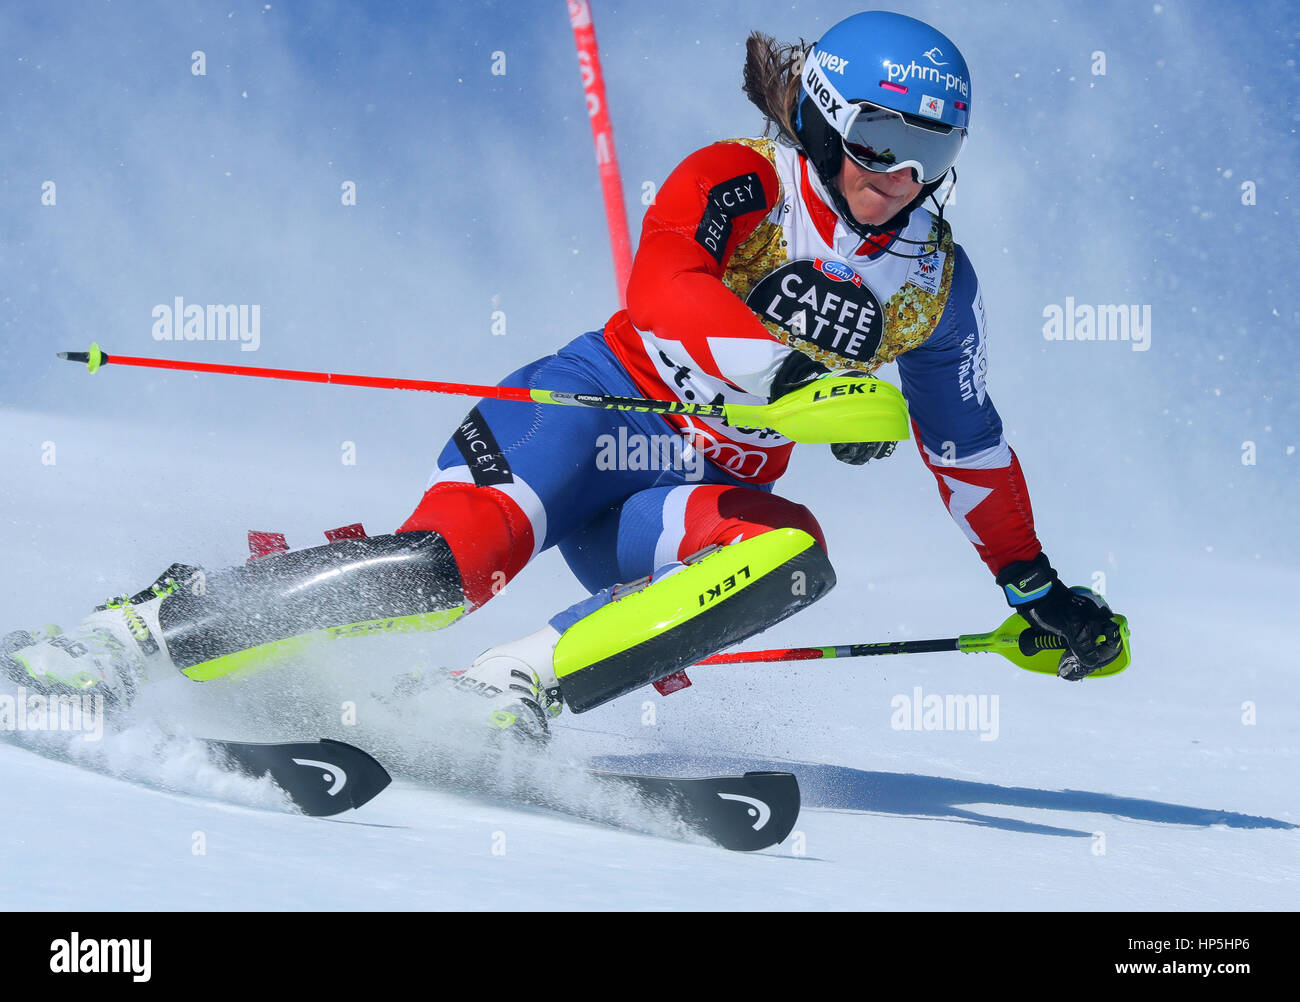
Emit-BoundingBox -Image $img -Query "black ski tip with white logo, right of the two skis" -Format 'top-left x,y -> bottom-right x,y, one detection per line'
588,769 -> 800,853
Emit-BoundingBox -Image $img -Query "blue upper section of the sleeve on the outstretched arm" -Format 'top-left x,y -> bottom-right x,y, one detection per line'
897,244 -> 1009,465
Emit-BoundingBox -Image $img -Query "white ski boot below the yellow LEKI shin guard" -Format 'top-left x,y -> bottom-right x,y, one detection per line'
447,625 -> 562,741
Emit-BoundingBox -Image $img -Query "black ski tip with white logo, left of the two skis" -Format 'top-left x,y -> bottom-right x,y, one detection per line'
200,738 -> 393,817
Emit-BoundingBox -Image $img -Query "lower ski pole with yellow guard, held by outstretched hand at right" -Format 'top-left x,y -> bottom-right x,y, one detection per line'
655,612 -> 1130,695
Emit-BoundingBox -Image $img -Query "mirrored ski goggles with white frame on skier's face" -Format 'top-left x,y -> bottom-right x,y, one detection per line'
841,101 -> 966,185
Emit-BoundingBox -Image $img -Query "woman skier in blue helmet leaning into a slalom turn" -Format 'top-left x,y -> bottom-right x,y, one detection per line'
0,12 -> 1122,736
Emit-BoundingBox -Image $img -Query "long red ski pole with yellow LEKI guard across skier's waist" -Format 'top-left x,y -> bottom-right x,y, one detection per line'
59,344 -> 909,443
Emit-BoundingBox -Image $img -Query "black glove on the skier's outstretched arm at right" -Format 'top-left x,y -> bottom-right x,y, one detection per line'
997,554 -> 1123,682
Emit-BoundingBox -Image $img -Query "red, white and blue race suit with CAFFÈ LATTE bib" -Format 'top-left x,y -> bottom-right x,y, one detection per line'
400,139 -> 1041,616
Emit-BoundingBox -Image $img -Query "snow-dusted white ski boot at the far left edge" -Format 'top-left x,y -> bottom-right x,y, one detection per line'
0,564 -> 195,708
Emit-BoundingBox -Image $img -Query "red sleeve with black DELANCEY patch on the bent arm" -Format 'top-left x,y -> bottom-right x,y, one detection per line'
628,143 -> 780,378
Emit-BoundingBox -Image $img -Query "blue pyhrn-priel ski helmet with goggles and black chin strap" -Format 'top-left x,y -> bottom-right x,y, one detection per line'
794,10 -> 971,235
